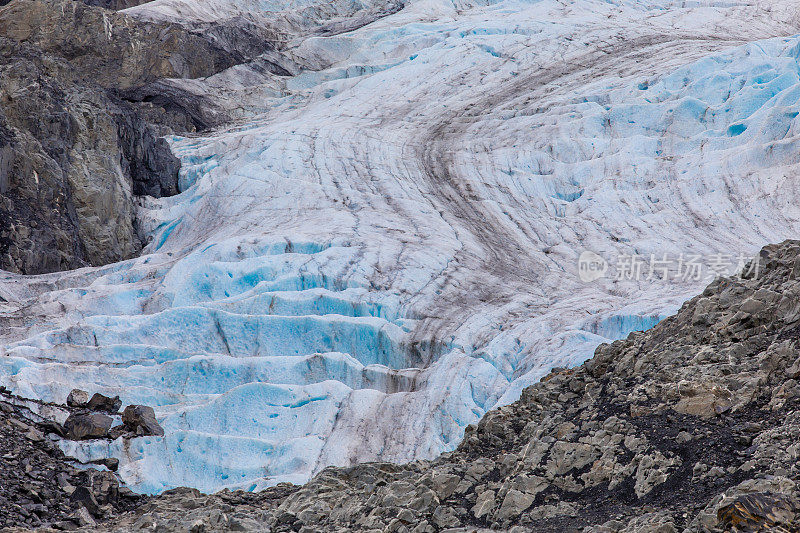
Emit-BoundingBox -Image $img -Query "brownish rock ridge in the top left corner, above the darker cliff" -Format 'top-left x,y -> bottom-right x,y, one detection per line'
0,0 -> 241,89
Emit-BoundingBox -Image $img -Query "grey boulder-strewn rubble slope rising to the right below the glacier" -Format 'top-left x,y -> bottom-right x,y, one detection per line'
92,241 -> 800,533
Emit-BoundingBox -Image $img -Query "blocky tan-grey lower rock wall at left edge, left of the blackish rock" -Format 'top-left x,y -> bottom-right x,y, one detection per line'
0,59 -> 141,273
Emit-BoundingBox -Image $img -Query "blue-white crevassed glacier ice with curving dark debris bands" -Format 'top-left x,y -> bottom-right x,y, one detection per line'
0,0 -> 800,492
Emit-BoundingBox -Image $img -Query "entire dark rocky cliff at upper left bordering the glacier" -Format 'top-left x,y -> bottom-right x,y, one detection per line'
0,0 -> 241,274
